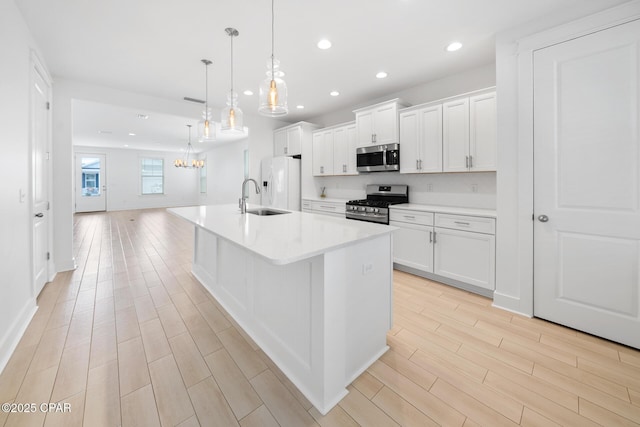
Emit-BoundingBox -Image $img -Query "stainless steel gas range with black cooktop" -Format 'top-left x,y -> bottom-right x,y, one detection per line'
345,185 -> 409,224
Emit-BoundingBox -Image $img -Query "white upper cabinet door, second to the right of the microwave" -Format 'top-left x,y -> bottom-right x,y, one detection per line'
418,105 -> 442,173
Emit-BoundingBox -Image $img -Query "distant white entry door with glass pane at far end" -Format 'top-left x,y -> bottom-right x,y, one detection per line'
76,153 -> 107,212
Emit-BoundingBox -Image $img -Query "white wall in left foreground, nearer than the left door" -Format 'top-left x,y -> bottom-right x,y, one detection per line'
0,0 -> 36,372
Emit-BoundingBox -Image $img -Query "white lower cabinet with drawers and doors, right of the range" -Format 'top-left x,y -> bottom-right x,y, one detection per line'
389,208 -> 496,291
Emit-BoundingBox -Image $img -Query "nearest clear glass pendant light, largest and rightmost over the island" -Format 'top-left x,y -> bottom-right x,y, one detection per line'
258,0 -> 289,117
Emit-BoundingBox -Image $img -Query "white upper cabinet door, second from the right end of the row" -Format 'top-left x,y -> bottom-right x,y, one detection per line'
442,98 -> 469,172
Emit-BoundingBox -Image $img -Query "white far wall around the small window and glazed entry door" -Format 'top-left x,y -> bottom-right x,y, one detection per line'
74,146 -> 199,211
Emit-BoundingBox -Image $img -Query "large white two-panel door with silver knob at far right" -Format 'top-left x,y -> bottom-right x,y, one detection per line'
534,21 -> 640,348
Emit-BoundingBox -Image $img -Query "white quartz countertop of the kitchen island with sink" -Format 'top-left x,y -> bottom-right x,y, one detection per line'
167,205 -> 396,265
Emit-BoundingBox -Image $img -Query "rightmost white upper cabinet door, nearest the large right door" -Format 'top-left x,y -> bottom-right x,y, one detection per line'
469,92 -> 497,171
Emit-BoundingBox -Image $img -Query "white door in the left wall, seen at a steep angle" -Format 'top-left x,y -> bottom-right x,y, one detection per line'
31,57 -> 51,296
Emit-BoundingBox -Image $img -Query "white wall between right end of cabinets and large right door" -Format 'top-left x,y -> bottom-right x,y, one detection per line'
494,0 -> 640,315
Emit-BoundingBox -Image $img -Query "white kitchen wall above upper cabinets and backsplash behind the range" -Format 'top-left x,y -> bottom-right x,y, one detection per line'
302,64 -> 496,209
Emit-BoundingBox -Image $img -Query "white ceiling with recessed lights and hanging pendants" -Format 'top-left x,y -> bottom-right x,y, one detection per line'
15,0 -> 623,152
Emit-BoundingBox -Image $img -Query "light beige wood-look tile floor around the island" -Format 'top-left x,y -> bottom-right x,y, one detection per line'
0,210 -> 640,427
